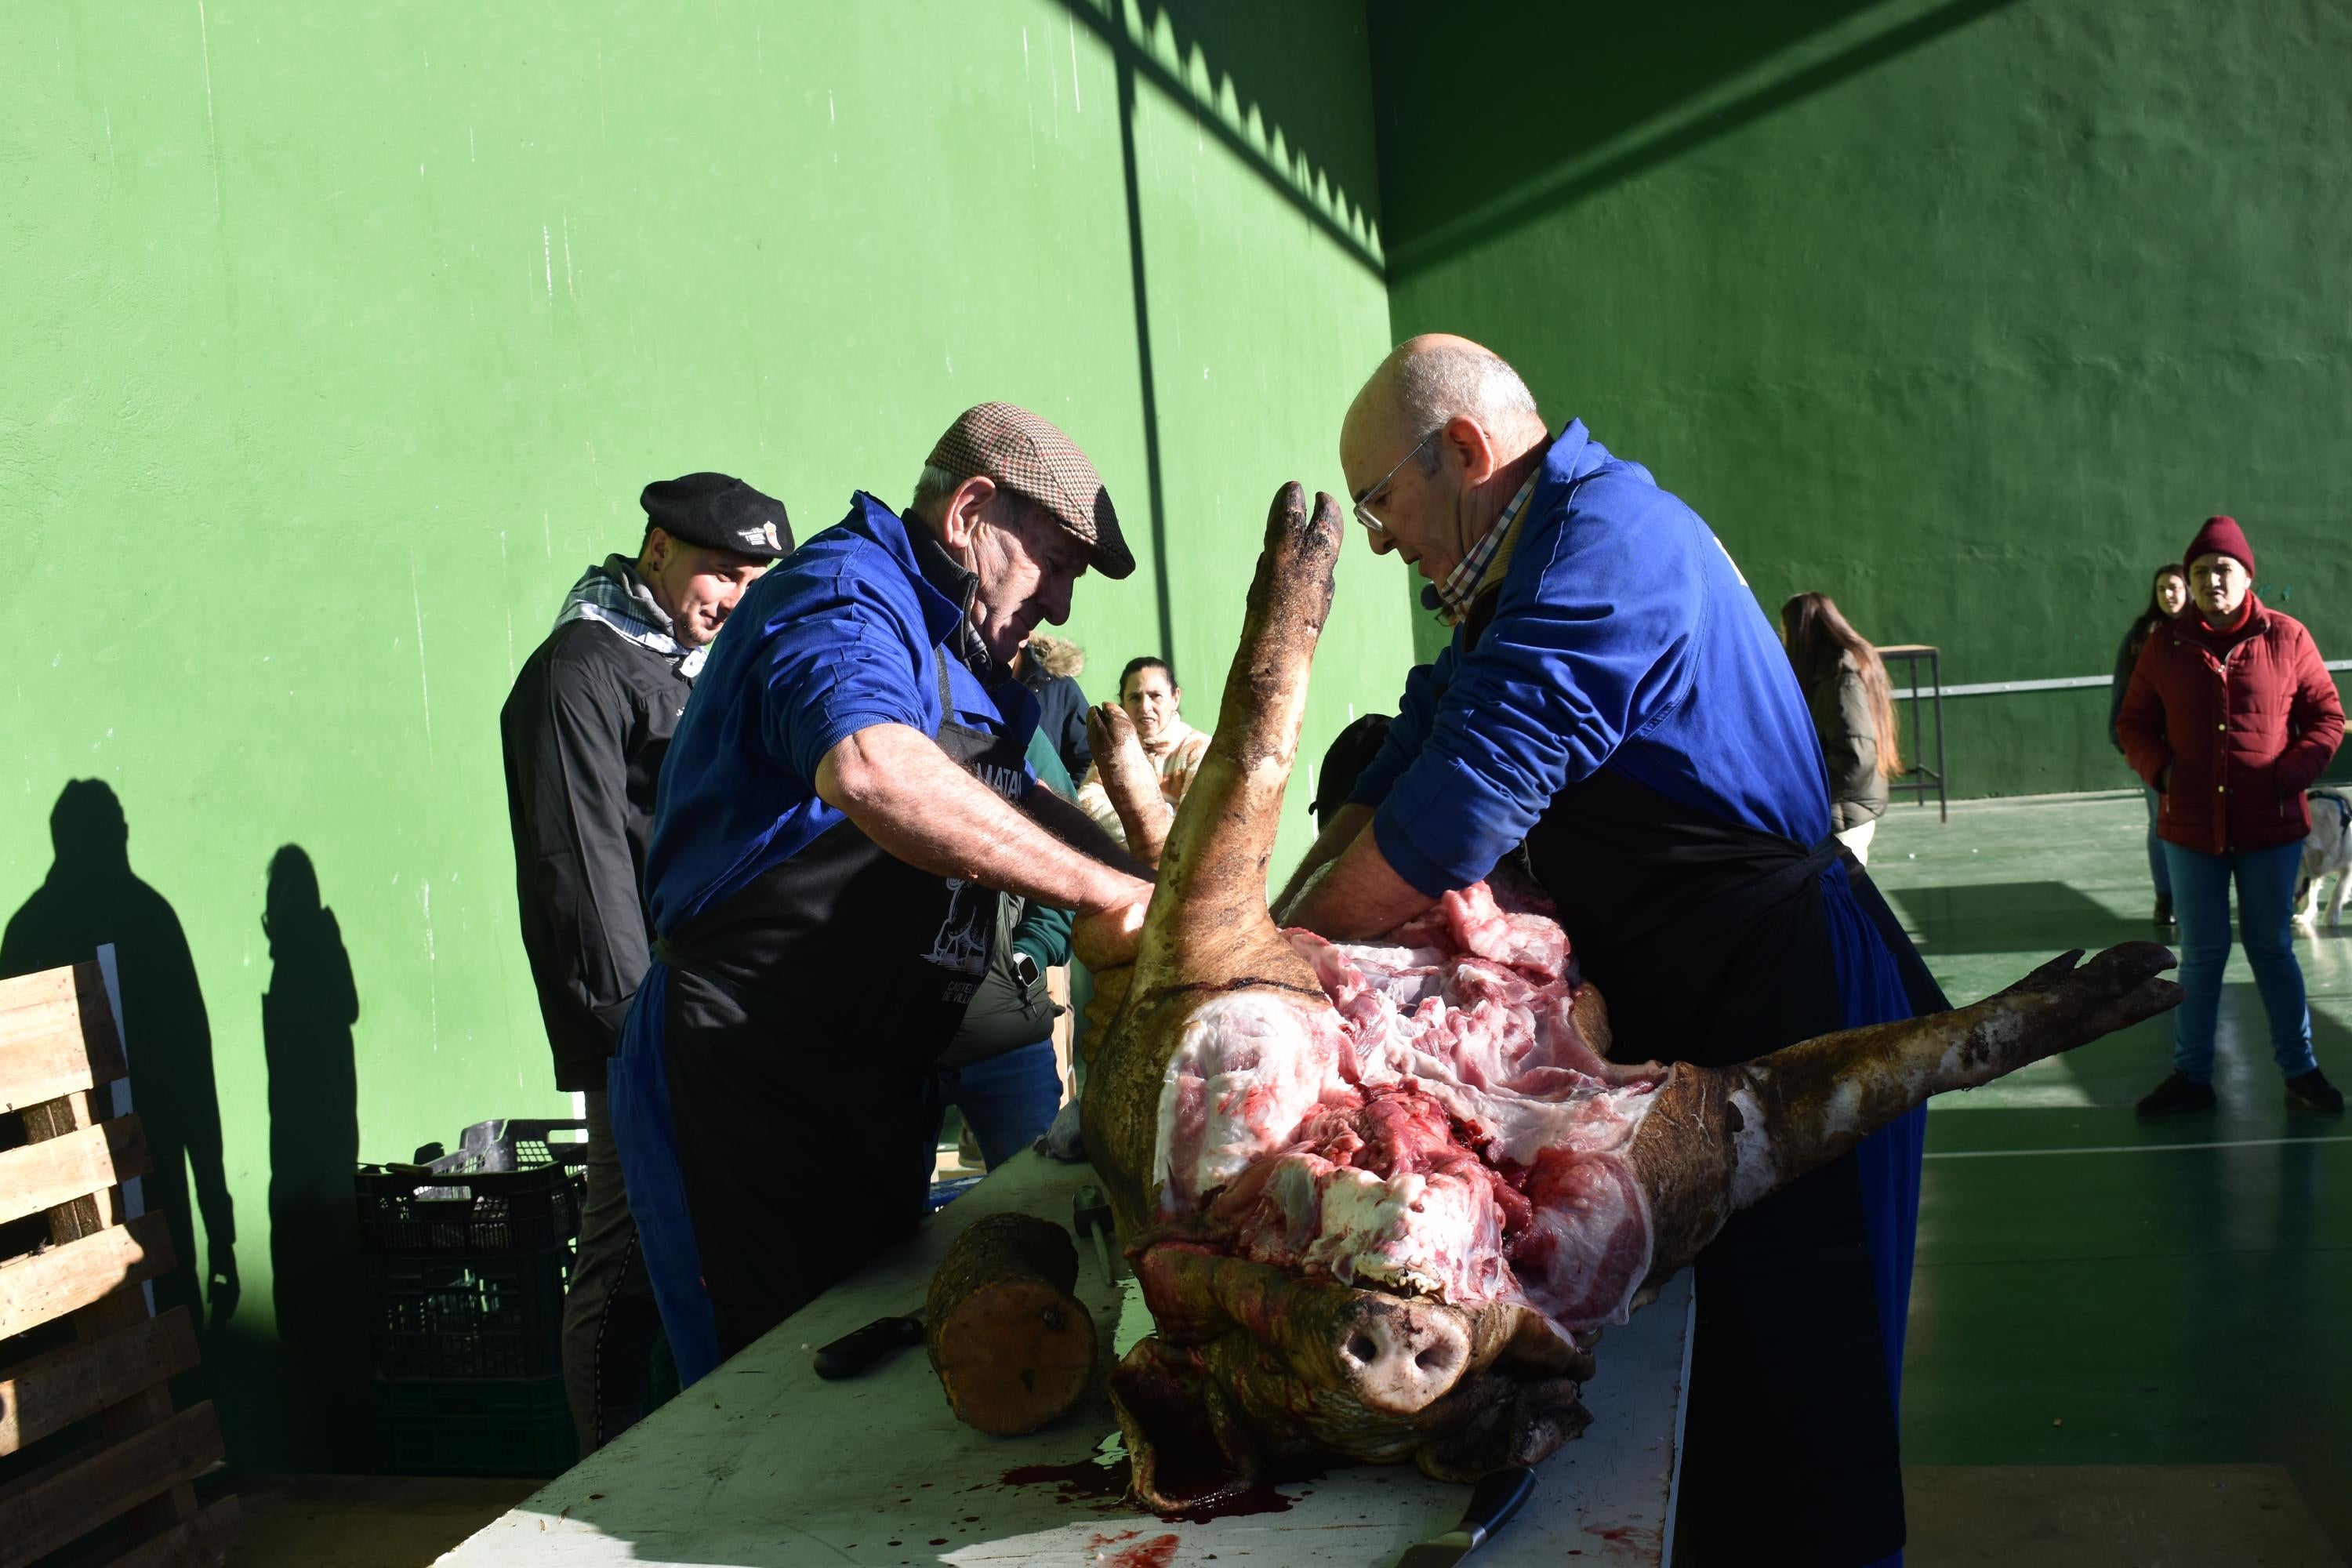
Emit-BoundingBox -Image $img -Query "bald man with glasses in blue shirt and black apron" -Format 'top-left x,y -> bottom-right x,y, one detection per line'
1284,336 -> 1943,1568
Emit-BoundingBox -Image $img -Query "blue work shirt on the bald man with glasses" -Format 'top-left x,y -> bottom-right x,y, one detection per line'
1350,421 -> 1830,895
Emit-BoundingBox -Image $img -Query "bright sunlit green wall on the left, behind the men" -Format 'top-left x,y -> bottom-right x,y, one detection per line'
0,0 -> 1411,1469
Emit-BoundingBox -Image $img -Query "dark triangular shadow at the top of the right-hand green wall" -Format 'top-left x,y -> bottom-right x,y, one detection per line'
1371,0 -> 2013,280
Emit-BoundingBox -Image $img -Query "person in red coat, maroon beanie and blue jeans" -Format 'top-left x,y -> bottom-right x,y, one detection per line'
2114,517 -> 2345,1116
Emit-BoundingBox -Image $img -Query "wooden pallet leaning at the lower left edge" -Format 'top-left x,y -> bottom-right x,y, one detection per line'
0,964 -> 238,1568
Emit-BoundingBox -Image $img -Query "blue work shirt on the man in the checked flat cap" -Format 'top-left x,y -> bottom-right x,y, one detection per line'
644,492 -> 1037,933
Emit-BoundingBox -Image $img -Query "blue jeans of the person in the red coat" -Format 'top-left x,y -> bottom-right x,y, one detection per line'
2164,841 -> 2319,1083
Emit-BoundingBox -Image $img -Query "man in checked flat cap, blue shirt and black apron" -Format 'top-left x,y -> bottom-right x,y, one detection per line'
609,402 -> 1150,1382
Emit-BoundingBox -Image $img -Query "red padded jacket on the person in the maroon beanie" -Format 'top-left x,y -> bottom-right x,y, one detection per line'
2114,593 -> 2345,855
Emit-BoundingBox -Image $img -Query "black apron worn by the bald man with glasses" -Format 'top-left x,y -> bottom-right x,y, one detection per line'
1465,602 -> 1943,1568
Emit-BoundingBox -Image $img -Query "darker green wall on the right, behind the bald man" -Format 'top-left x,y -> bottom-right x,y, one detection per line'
1371,0 -> 2352,794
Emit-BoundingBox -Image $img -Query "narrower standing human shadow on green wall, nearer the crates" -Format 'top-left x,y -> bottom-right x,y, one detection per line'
261,844 -> 367,1469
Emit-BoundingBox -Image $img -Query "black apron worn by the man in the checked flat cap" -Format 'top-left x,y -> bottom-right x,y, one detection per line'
661,654 -> 1025,1356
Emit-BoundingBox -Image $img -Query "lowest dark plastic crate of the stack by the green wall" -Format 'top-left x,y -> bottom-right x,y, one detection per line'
374,1377 -> 579,1476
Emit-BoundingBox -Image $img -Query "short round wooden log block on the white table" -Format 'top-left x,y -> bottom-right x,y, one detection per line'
922,1213 -> 1094,1436
